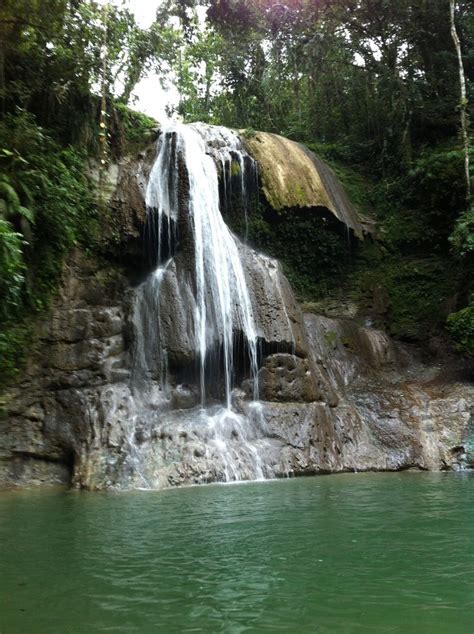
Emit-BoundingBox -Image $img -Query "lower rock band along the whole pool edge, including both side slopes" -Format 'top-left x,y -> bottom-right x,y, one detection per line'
0,249 -> 474,489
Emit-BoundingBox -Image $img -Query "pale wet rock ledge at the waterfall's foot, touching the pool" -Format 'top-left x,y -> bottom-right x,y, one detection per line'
75,390 -> 288,489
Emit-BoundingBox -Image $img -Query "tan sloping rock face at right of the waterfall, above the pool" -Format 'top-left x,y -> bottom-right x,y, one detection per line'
305,315 -> 474,470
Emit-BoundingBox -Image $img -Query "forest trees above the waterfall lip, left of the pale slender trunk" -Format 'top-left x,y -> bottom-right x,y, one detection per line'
169,0 -> 472,165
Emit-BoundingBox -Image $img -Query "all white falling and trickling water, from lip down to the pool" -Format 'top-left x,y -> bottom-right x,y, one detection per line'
128,124 -> 282,481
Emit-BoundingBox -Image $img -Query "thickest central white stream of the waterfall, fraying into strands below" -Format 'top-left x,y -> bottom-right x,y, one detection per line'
183,127 -> 258,409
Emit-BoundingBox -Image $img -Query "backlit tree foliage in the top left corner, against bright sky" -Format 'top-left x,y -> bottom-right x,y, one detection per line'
0,0 -> 181,150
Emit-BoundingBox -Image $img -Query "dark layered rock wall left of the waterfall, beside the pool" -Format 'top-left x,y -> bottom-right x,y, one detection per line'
0,254 -> 130,485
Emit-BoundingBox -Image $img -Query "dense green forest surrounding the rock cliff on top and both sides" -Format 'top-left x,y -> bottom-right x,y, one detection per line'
0,0 -> 474,384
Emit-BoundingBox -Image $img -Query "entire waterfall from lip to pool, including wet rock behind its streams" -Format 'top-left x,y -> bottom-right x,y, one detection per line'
124,124 -> 281,488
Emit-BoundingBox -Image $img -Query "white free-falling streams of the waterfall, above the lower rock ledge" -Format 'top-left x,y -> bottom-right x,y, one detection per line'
138,123 -> 258,410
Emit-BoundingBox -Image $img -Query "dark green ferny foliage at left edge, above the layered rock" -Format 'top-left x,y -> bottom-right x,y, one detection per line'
0,110 -> 98,383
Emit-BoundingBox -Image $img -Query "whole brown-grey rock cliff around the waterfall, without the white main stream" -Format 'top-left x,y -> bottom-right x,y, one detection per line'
0,126 -> 474,489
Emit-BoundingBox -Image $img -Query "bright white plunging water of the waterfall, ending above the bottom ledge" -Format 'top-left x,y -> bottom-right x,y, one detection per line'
146,124 -> 258,409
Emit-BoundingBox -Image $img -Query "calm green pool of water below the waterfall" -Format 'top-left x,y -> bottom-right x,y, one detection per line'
0,473 -> 474,634
